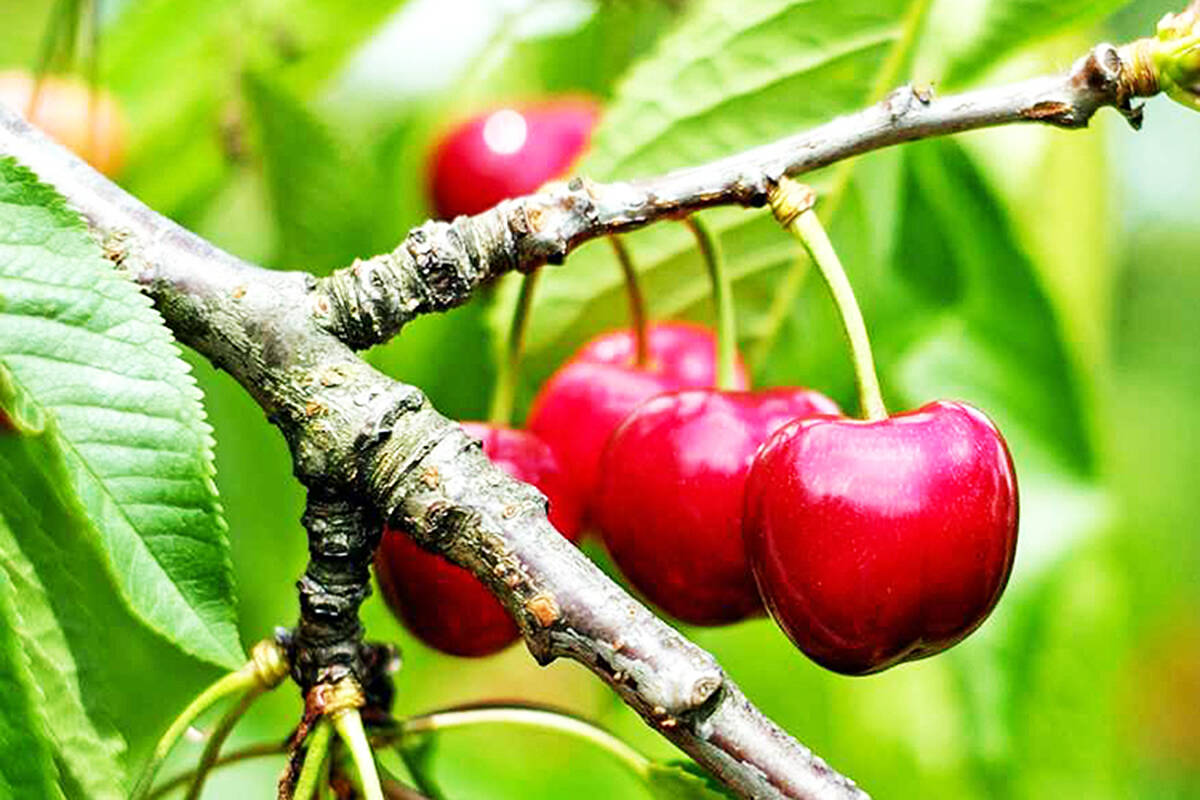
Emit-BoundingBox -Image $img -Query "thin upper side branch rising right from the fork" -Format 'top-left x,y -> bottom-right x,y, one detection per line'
316,44 -> 1158,349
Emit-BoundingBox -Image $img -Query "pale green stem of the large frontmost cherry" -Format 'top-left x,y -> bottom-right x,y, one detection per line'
770,178 -> 888,420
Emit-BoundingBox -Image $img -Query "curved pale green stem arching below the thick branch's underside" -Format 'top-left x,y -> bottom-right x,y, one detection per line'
398,705 -> 650,778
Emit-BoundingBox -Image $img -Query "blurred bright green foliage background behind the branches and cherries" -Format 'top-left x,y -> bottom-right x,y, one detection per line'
0,0 -> 1200,799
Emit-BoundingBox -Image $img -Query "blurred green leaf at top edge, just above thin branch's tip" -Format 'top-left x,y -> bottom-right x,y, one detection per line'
942,0 -> 1129,86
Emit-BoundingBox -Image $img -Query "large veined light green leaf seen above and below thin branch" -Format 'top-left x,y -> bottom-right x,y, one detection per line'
491,0 -> 926,400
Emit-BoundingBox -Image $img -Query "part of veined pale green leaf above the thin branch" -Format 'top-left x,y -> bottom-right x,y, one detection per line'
582,0 -> 920,179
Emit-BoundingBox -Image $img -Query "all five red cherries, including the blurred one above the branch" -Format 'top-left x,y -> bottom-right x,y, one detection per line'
377,100 -> 1018,674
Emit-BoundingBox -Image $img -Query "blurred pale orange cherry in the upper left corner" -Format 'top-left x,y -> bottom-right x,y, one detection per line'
0,70 -> 128,175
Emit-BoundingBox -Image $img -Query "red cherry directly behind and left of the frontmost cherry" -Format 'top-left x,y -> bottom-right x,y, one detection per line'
594,389 -> 838,625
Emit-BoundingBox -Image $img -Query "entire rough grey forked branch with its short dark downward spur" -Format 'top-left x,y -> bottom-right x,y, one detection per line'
0,28 -> 1180,799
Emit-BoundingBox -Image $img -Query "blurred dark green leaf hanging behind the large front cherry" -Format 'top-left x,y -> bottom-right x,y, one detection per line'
888,139 -> 1108,588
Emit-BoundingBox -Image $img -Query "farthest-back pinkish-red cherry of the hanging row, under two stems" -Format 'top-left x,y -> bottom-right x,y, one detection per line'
526,323 -> 748,515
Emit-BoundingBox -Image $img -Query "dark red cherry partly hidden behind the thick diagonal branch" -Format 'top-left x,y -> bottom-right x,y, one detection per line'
376,422 -> 580,656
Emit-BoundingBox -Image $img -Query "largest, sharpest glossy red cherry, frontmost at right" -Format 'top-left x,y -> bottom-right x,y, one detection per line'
744,402 -> 1018,675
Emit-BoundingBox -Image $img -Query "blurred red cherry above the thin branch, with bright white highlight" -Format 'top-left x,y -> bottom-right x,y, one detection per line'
430,97 -> 600,218
